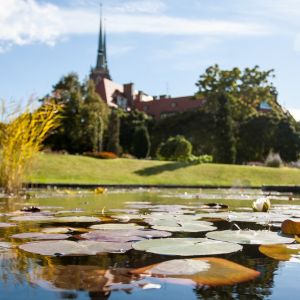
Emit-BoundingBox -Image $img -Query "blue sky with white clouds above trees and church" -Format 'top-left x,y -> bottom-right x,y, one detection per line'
0,0 -> 300,120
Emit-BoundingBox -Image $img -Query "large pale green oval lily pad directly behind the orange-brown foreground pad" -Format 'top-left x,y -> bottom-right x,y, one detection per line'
132,238 -> 242,256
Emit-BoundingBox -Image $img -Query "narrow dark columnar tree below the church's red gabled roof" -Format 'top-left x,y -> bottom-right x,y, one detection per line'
107,110 -> 121,155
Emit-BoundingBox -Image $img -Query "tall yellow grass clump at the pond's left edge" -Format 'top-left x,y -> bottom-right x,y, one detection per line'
0,100 -> 61,193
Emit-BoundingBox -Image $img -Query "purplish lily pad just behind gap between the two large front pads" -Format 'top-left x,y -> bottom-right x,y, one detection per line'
80,229 -> 171,242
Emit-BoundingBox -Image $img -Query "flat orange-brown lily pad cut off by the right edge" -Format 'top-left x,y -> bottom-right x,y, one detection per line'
258,244 -> 300,262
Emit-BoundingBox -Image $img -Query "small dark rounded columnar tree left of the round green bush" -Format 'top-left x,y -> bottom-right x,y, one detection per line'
132,126 -> 151,158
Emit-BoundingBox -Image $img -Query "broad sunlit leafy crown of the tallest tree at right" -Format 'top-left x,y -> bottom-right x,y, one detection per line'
196,65 -> 285,122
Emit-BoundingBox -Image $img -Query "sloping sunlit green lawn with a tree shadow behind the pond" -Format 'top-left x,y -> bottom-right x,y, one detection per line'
27,154 -> 300,186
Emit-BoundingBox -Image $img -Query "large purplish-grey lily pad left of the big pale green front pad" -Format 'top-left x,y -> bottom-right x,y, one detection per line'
19,241 -> 131,256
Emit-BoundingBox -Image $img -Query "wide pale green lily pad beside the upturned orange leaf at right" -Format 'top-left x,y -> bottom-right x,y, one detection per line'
206,230 -> 295,245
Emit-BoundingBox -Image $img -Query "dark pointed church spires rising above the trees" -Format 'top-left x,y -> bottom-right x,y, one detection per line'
90,5 -> 111,85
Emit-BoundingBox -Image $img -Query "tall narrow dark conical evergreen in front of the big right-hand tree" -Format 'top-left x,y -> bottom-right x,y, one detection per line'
214,94 -> 236,164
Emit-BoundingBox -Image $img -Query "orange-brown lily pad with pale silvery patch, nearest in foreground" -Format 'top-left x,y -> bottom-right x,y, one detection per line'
131,257 -> 260,286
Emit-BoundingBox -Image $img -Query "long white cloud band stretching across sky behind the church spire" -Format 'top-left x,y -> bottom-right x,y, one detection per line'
0,0 -> 268,51
